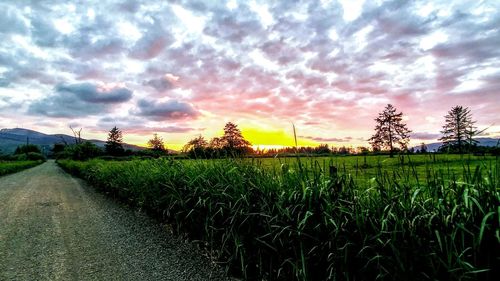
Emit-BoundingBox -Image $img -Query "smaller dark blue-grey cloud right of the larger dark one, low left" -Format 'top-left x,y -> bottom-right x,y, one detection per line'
134,99 -> 199,121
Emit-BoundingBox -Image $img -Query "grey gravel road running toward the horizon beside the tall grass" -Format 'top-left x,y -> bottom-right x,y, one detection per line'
0,161 -> 229,280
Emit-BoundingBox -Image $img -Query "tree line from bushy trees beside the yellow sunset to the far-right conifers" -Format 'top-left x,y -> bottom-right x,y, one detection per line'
179,104 -> 492,158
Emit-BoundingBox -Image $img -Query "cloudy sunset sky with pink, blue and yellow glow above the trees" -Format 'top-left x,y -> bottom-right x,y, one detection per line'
0,0 -> 500,149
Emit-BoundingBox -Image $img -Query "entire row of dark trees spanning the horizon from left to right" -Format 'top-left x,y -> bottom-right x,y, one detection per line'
7,104 -> 499,160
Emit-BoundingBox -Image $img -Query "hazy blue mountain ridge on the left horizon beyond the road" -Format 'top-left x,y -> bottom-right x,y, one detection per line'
0,128 -> 144,154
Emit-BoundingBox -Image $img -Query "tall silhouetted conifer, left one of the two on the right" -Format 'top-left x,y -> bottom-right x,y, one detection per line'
369,104 -> 411,157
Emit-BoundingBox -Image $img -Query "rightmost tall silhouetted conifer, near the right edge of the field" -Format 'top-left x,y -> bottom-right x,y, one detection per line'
439,105 -> 478,153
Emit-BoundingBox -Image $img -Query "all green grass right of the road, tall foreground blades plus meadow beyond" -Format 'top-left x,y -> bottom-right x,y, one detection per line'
59,155 -> 500,280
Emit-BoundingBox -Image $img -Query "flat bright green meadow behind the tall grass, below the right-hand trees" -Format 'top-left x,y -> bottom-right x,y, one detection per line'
248,154 -> 498,184
